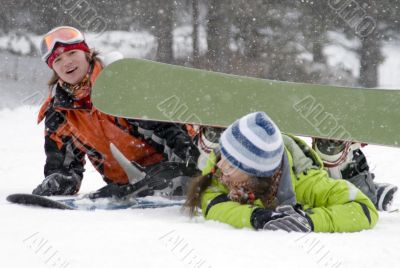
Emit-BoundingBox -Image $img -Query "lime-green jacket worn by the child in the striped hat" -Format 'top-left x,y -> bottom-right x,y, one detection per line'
201,135 -> 378,232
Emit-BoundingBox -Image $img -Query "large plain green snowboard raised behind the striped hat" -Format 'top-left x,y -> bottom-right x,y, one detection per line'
92,59 -> 400,146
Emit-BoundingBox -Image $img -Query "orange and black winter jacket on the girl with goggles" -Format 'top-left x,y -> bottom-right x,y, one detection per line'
38,62 -> 198,184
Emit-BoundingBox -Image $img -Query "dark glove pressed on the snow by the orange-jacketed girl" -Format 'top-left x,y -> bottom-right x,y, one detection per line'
32,172 -> 82,196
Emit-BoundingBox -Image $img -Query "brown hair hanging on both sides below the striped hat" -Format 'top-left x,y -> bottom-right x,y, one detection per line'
184,156 -> 283,217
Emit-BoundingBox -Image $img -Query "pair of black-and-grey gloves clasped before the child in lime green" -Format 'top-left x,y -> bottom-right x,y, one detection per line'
251,205 -> 313,233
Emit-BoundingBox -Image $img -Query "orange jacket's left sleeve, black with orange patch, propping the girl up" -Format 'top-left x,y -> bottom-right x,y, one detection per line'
44,105 -> 85,177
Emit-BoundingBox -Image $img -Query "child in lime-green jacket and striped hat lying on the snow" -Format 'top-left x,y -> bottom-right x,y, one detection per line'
186,112 -> 378,232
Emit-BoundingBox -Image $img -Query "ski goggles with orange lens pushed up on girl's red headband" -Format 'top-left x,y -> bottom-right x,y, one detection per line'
40,26 -> 85,62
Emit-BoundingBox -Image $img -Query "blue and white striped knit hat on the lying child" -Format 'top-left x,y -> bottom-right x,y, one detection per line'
220,112 -> 284,177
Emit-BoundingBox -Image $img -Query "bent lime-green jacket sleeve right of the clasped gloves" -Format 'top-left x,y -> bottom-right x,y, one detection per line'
294,169 -> 378,232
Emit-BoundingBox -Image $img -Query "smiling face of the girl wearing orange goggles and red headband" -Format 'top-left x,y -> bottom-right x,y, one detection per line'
53,49 -> 89,85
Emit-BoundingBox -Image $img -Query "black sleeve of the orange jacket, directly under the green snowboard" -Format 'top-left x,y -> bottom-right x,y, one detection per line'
127,119 -> 200,164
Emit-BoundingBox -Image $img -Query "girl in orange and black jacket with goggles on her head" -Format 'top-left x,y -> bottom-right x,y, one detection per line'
33,26 -> 199,195
